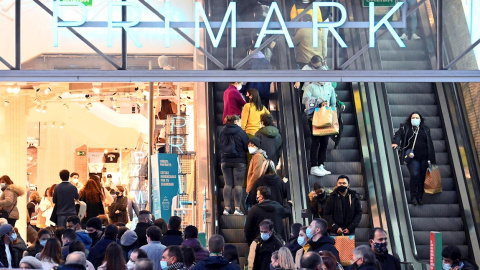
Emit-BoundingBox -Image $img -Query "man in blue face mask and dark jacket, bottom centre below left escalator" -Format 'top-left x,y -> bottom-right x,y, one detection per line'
248,219 -> 283,270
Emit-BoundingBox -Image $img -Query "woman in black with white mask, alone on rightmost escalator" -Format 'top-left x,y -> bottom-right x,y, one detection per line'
392,112 -> 436,205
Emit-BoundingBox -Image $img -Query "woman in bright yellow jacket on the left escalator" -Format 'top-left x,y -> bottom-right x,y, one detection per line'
241,88 -> 270,138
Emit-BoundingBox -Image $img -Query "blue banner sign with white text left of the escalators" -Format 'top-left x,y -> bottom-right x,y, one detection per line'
152,154 -> 180,220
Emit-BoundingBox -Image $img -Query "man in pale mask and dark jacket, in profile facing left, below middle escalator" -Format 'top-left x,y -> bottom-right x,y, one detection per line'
306,218 -> 340,262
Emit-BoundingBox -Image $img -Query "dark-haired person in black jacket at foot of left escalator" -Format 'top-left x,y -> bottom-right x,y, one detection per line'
245,186 -> 291,245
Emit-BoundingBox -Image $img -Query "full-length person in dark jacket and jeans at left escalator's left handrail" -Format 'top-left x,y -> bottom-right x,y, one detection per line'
218,115 -> 248,215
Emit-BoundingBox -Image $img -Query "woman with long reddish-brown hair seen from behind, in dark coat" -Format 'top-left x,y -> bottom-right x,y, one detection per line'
80,179 -> 105,223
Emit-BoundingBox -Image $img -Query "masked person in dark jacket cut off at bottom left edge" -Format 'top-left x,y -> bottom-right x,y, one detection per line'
0,224 -> 22,268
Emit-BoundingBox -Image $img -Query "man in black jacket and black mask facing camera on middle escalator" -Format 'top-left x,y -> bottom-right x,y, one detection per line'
324,175 -> 362,235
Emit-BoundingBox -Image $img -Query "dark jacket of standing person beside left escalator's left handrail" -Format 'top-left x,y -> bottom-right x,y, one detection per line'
218,124 -> 248,164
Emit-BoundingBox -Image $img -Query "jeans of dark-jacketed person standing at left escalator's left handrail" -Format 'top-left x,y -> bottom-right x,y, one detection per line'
221,162 -> 247,209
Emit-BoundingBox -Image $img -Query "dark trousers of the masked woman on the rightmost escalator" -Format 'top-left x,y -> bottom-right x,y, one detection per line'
407,159 -> 428,200
